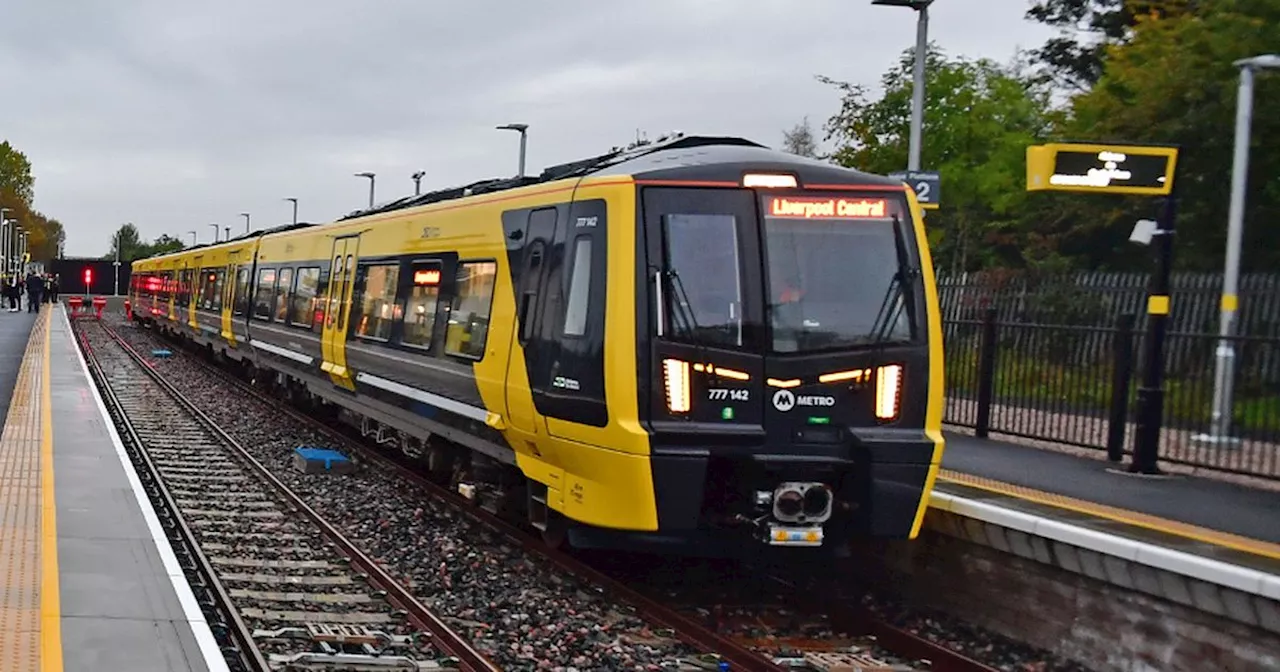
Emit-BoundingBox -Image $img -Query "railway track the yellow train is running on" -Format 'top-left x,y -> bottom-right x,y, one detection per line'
102,316 -> 995,672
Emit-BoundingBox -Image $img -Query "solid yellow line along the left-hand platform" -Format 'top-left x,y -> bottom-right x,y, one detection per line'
40,303 -> 63,672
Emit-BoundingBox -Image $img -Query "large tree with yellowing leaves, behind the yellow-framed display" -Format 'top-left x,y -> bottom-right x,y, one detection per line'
1059,0 -> 1280,271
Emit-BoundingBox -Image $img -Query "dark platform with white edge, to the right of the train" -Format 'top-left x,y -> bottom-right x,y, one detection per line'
931,434 -> 1280,591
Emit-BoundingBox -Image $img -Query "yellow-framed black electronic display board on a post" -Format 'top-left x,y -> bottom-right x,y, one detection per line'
1027,143 -> 1178,196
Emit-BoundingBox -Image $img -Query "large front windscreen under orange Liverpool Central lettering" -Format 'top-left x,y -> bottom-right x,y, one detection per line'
763,196 -> 914,352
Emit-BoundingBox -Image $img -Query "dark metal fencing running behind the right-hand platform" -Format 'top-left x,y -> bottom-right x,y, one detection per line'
942,271 -> 1280,479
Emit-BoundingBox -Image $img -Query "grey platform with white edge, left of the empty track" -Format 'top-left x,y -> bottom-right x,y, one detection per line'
0,305 -> 227,672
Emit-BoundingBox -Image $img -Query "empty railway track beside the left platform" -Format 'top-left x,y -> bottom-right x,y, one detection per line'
76,320 -> 499,672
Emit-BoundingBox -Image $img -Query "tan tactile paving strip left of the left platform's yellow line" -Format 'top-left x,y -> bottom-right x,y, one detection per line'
0,310 -> 49,672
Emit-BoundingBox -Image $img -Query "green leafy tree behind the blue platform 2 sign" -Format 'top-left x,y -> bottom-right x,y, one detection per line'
819,46 -> 1053,270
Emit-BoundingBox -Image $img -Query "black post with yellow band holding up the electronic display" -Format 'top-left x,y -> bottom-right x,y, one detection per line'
1129,183 -> 1178,474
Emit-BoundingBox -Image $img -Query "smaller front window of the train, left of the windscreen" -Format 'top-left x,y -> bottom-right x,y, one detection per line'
663,215 -> 742,346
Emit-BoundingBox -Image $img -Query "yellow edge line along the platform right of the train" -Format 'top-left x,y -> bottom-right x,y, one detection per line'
931,468 -> 1280,559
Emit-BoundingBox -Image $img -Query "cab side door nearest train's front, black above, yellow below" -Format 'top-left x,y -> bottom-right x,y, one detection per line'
504,207 -> 557,434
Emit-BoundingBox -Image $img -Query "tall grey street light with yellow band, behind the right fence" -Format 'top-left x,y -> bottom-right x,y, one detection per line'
1196,54 -> 1280,444
